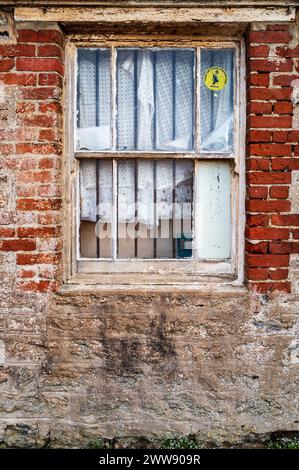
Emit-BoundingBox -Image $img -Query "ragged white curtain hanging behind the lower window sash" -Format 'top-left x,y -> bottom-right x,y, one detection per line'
80,159 -> 193,228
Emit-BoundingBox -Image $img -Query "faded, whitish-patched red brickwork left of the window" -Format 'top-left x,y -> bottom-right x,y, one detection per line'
0,27 -> 64,291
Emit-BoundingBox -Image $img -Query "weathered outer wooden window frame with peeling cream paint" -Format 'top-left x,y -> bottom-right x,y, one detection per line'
65,35 -> 246,283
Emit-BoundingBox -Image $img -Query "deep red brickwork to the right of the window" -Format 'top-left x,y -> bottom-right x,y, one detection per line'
245,25 -> 299,292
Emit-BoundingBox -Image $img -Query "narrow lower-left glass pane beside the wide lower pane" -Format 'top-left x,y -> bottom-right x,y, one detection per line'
80,160 -> 113,258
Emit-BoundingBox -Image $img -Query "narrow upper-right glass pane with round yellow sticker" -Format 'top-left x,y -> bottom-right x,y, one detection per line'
200,49 -> 234,152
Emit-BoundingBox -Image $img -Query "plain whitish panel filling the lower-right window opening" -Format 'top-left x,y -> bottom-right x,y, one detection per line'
195,161 -> 231,259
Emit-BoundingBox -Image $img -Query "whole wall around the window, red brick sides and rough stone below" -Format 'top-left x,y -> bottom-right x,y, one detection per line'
0,8 -> 299,447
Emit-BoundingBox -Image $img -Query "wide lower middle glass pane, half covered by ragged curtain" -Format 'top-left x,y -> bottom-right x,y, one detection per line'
117,159 -> 193,259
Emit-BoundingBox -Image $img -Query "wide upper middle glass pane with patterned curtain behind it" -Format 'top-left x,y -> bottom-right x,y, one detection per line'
117,49 -> 195,152
